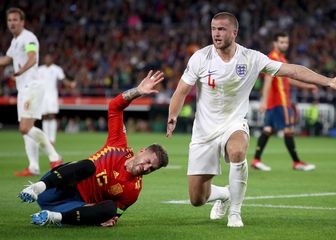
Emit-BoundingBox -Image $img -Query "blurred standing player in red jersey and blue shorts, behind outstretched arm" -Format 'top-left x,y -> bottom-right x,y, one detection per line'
251,32 -> 318,171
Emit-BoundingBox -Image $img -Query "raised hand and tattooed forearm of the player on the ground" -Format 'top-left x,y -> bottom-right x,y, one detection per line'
122,70 -> 164,102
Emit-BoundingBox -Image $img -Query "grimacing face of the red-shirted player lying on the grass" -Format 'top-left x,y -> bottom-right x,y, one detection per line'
126,149 -> 159,176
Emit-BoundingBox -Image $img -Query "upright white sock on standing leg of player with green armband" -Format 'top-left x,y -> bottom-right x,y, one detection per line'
23,134 -> 40,174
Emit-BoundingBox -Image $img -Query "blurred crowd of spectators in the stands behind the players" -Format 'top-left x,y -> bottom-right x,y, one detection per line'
0,0 -> 336,104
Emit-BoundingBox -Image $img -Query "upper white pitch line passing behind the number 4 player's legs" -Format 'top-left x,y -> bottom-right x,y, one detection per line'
162,192 -> 336,204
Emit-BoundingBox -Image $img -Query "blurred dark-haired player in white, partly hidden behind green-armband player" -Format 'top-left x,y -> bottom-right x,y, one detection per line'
38,54 -> 76,144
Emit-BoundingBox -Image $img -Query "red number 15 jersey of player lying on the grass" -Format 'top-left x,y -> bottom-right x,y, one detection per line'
77,94 -> 142,210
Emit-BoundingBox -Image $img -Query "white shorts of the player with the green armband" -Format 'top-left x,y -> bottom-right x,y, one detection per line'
17,84 -> 44,122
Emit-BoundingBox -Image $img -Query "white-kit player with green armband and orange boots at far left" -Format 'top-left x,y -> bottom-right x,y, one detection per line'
0,8 -> 62,176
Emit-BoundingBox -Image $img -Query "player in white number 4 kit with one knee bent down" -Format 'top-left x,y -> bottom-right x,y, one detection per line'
167,12 -> 336,227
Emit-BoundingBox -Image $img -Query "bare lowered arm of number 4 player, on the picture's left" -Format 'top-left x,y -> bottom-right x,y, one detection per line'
166,79 -> 193,137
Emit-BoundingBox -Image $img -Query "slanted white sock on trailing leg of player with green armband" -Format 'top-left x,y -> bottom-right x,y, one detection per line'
27,127 -> 60,162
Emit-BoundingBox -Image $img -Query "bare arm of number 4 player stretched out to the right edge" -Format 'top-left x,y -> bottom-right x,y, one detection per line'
276,63 -> 336,89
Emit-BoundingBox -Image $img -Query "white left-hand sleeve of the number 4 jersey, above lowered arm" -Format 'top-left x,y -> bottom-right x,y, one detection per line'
181,51 -> 201,86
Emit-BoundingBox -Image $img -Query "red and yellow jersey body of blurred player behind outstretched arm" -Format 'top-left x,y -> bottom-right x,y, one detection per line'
267,50 -> 291,109
